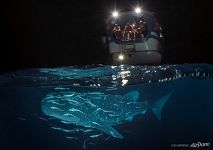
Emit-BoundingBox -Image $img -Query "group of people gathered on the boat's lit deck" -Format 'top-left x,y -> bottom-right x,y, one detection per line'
112,19 -> 148,41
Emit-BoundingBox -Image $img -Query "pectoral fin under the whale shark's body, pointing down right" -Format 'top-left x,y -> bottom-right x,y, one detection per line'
92,121 -> 123,139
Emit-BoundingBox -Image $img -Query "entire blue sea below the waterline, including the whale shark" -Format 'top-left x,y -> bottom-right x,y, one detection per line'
0,64 -> 213,150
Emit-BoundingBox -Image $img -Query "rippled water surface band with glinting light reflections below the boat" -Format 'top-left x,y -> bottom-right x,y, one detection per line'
0,64 -> 213,88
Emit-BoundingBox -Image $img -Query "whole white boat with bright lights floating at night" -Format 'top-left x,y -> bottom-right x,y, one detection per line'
106,8 -> 163,65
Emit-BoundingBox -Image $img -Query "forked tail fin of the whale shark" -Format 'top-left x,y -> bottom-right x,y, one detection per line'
152,91 -> 174,120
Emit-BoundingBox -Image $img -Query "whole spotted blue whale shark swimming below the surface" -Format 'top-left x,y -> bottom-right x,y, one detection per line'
41,91 -> 173,139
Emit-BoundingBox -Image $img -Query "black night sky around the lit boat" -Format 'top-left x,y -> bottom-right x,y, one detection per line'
0,0 -> 213,71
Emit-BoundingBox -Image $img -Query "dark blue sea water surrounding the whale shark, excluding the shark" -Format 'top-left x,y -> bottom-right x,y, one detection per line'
0,64 -> 213,150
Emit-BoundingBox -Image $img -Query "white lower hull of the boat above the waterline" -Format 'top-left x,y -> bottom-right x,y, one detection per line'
109,38 -> 162,65
